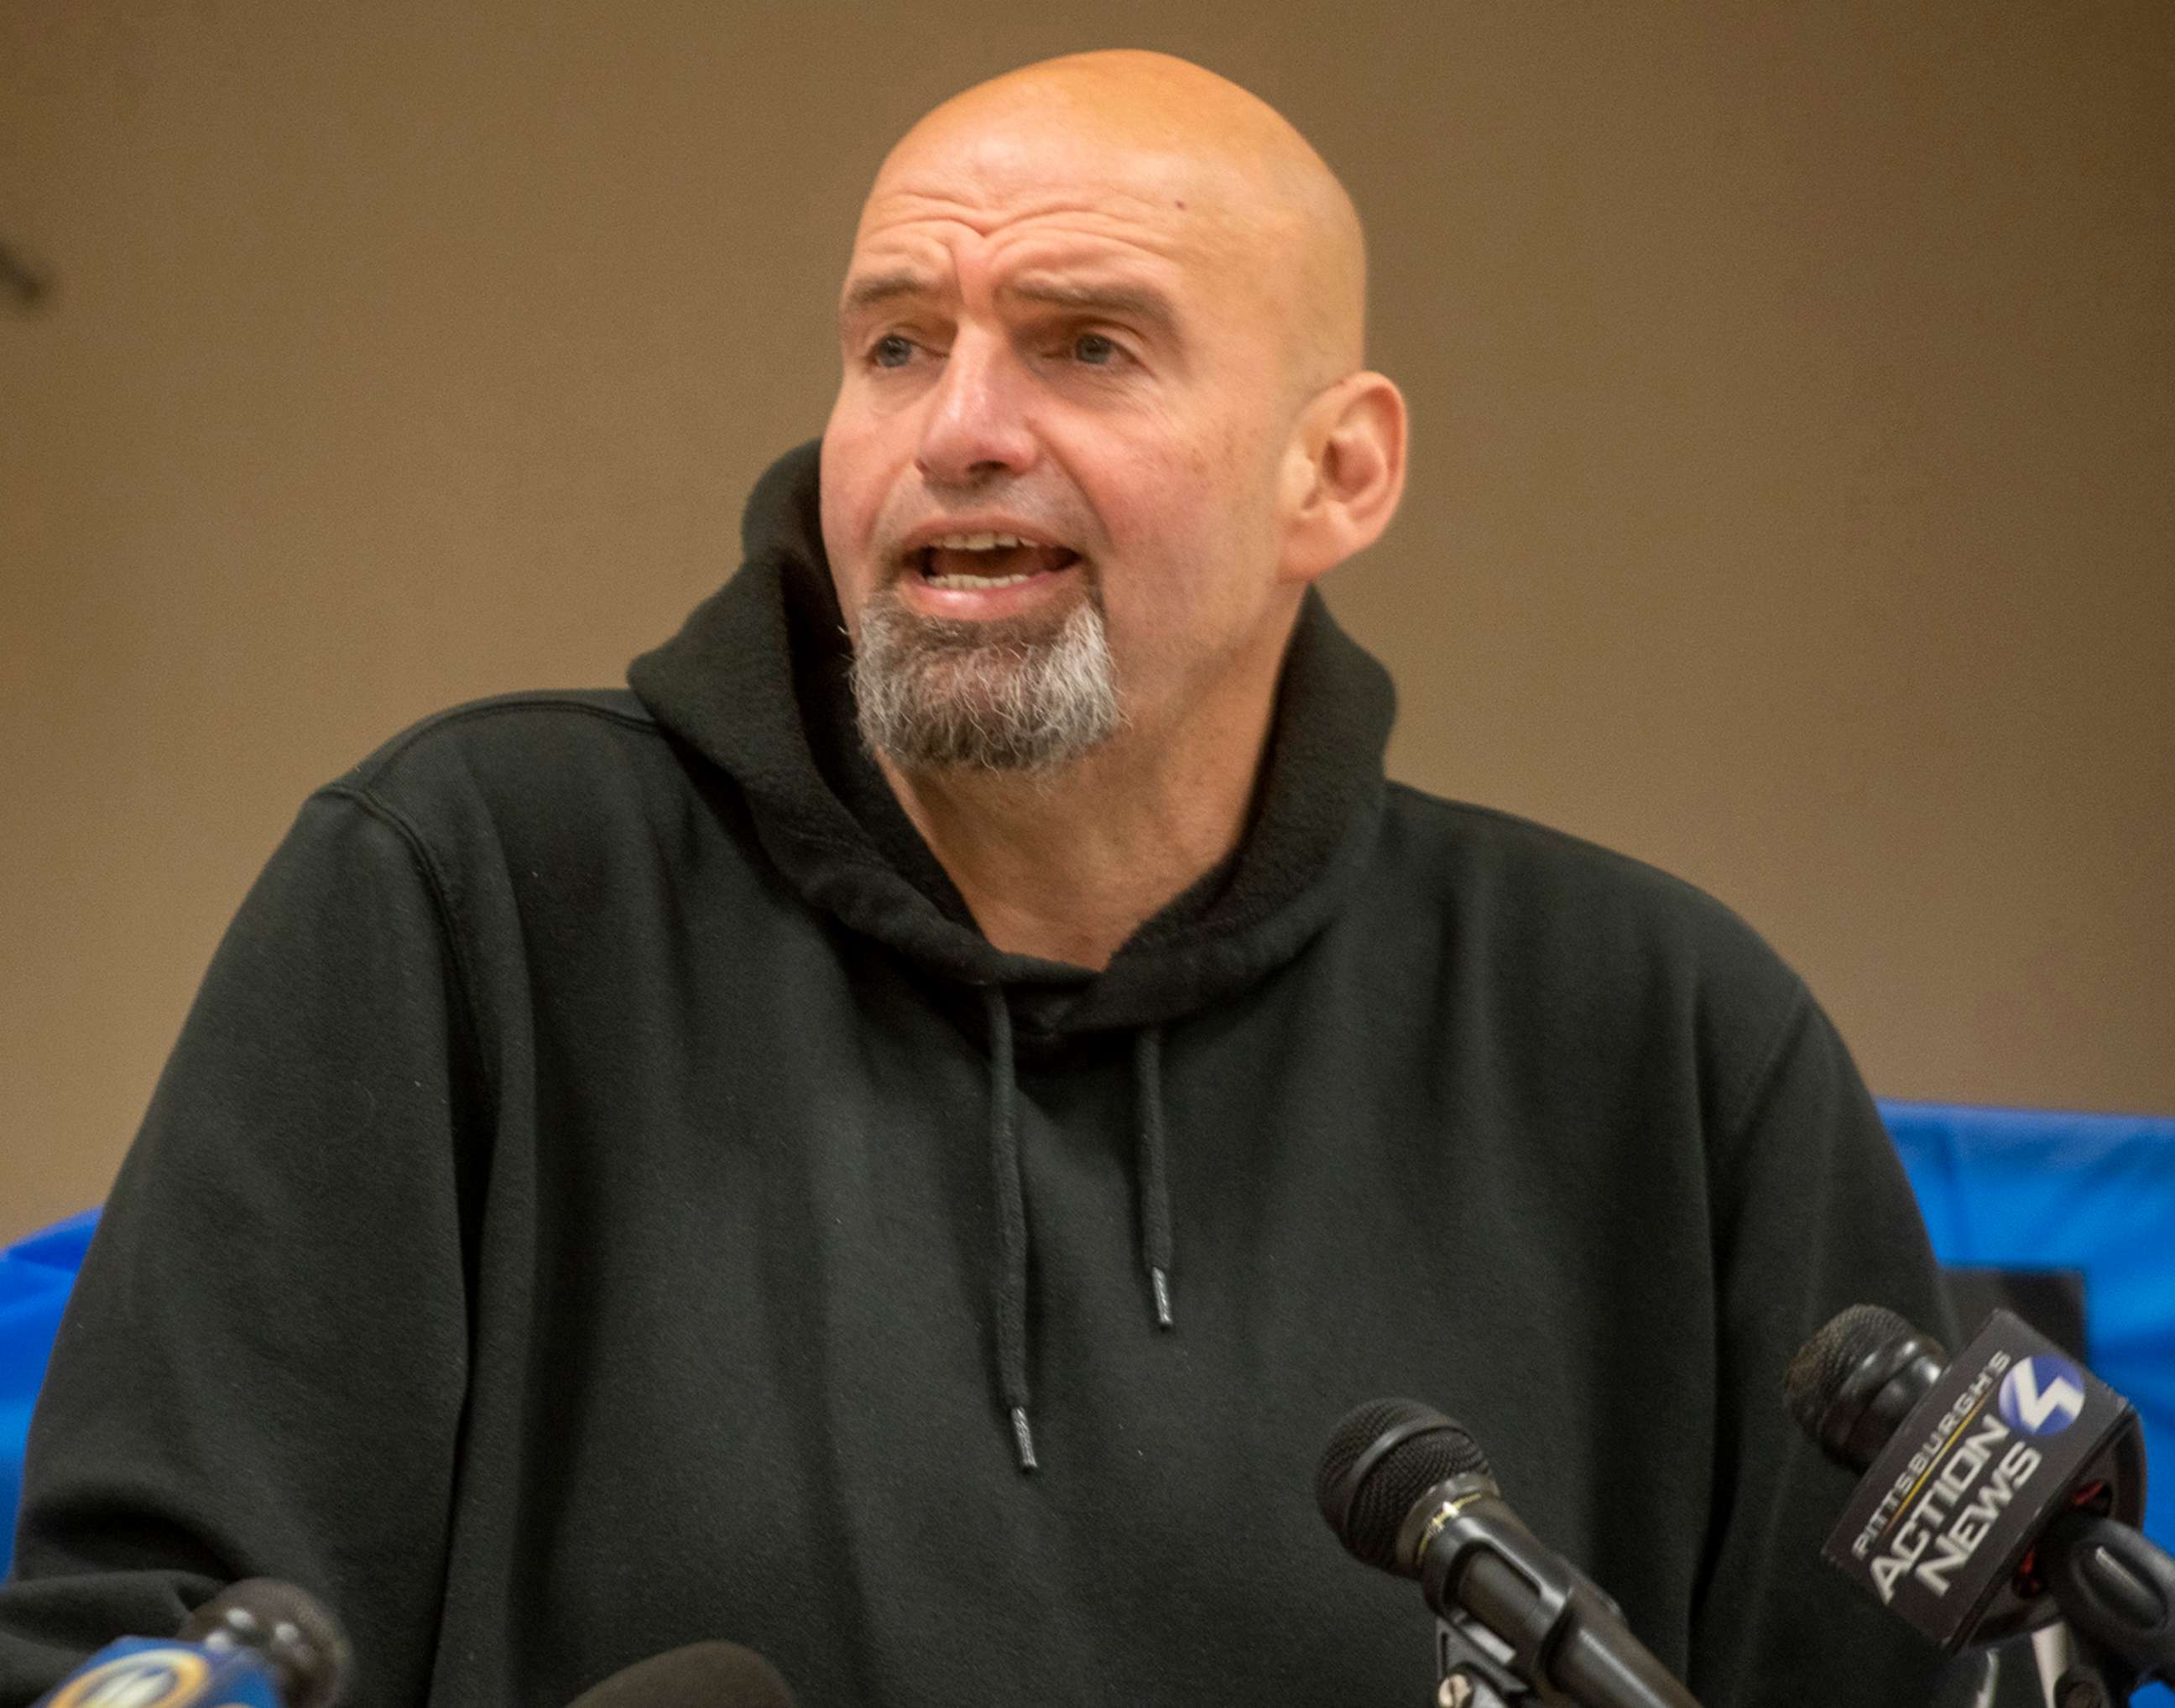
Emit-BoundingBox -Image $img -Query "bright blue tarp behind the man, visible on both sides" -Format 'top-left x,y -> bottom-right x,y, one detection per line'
0,1103 -> 2175,1627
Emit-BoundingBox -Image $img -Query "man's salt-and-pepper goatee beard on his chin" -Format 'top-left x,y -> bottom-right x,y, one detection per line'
853,587 -> 1122,773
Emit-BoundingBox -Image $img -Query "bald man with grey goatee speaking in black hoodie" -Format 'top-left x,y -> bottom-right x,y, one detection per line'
0,55 -> 1943,1708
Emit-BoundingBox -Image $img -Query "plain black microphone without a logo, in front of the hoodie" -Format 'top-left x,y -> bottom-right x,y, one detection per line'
1314,1399 -> 1698,1708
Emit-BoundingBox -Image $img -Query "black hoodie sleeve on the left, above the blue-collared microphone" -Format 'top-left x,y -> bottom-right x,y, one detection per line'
0,792 -> 474,1708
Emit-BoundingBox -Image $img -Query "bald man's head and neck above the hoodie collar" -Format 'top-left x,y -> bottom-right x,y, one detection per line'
822,52 -> 1405,968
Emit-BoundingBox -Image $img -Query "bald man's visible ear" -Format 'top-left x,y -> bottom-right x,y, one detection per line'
1279,372 -> 1405,581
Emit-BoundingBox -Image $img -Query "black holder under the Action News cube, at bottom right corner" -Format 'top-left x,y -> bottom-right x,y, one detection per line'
2040,1513 -> 2175,1708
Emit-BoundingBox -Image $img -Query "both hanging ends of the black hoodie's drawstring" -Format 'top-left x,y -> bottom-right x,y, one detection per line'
983,983 -> 1172,1471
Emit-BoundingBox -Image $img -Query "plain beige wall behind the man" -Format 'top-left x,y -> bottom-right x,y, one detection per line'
0,0 -> 2175,1238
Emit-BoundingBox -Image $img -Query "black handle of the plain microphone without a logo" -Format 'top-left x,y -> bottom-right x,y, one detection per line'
1421,1497 -> 1698,1708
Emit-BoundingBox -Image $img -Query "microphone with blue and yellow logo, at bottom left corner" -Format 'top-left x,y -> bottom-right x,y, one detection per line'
39,1577 -> 352,1708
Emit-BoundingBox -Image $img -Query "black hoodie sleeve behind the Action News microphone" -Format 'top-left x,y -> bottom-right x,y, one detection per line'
1690,992 -> 1955,1708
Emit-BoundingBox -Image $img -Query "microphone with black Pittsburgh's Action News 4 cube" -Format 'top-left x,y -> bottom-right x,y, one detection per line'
1783,1305 -> 2175,1671
